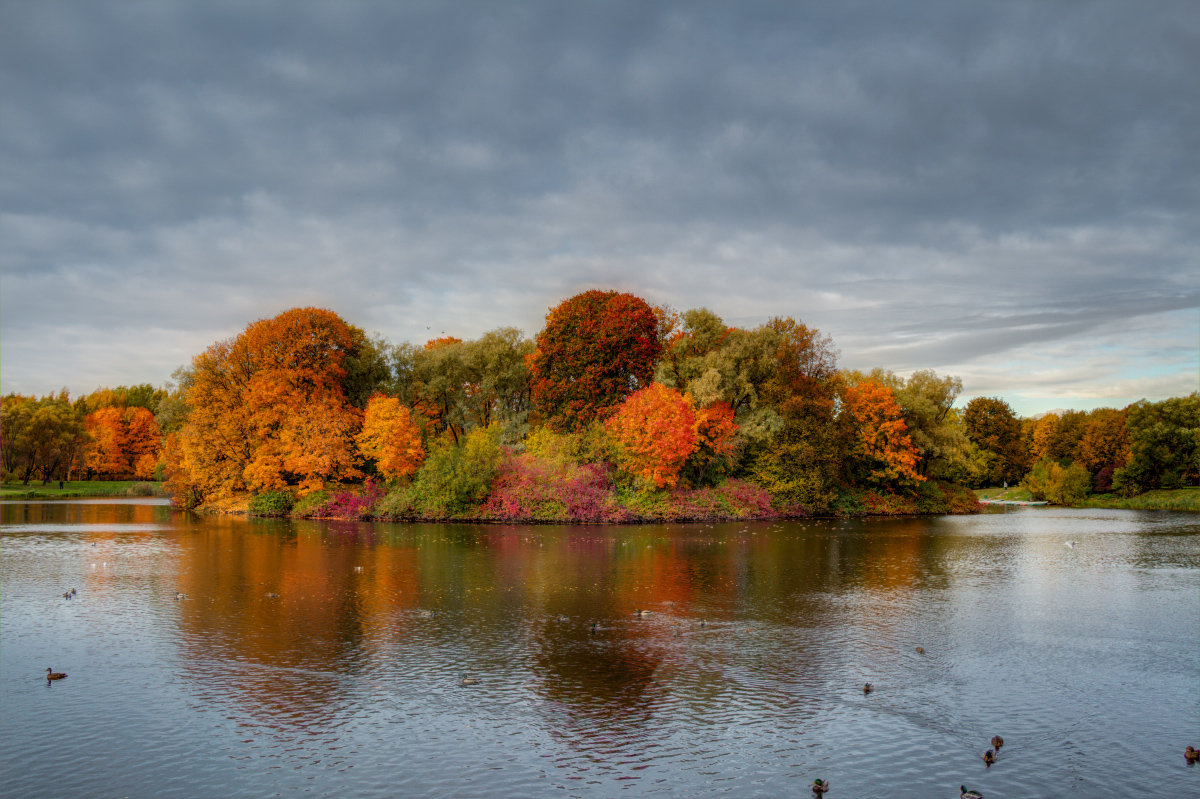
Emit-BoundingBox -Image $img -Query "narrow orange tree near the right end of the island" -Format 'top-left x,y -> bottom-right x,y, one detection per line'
841,379 -> 924,487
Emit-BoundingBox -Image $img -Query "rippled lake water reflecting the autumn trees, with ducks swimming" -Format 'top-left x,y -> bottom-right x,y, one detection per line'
0,499 -> 1200,799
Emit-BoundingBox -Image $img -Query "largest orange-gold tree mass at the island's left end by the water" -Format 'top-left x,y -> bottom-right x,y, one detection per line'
167,308 -> 365,498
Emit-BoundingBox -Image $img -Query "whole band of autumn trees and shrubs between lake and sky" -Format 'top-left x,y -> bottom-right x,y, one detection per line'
0,290 -> 1200,523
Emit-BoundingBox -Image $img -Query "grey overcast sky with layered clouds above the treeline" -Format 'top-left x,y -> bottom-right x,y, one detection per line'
0,0 -> 1200,414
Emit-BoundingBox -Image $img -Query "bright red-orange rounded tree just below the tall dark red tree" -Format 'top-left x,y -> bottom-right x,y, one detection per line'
605,383 -> 700,488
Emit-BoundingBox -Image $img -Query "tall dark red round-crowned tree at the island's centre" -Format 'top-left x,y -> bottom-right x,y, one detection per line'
529,290 -> 661,431
